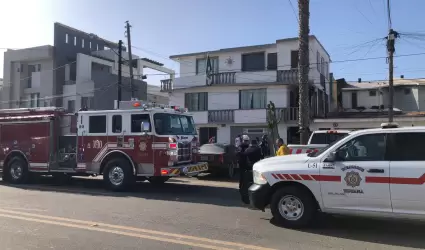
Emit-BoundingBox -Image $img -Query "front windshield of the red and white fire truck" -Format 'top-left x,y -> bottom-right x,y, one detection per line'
153,113 -> 196,135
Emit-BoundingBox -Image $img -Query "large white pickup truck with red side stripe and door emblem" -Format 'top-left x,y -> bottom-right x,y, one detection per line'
249,124 -> 425,227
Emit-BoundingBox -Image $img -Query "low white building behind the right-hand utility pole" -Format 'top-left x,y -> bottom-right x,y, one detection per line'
311,78 -> 425,130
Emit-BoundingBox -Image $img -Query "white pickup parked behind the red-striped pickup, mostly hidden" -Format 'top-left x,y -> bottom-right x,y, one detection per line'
288,130 -> 350,154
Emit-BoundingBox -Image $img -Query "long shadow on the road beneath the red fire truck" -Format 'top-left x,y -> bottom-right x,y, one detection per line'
0,177 -> 242,207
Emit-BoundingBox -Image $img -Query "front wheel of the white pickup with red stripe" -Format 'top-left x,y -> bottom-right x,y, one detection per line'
270,187 -> 317,228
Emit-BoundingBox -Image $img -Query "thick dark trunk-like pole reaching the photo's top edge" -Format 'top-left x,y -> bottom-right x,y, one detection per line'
298,0 -> 310,144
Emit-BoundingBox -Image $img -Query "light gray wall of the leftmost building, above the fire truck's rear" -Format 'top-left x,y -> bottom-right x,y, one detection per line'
1,45 -> 54,108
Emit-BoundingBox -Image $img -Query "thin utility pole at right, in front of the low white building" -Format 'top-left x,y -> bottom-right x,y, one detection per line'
387,29 -> 399,122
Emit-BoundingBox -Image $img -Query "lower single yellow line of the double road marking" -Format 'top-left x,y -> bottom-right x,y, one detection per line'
0,213 -> 232,250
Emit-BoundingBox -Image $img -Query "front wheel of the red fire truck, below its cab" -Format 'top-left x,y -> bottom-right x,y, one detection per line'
103,158 -> 135,191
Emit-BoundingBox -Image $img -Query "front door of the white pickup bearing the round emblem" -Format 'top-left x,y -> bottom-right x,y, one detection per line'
320,133 -> 392,212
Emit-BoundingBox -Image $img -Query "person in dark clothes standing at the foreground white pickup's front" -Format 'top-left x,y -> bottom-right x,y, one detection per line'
239,140 -> 263,204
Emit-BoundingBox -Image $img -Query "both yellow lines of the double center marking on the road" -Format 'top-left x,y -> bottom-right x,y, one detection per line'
0,208 -> 274,250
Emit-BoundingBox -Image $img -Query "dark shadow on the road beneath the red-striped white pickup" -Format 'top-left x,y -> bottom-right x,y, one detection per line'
271,214 -> 425,249
